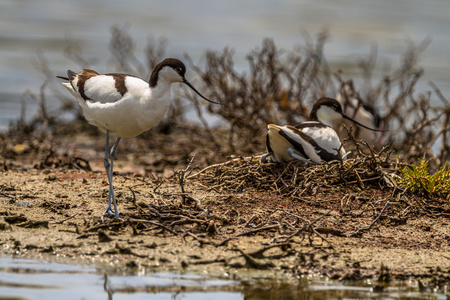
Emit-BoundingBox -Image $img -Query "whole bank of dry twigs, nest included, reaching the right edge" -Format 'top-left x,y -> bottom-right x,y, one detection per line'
180,141 -> 450,222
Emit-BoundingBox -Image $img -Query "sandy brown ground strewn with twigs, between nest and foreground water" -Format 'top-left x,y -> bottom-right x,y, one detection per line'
0,130 -> 450,285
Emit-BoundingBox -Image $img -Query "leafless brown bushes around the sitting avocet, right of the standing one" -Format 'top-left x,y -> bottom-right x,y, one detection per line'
190,32 -> 450,168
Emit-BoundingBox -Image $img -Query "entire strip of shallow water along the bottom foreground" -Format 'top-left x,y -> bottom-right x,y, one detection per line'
0,257 -> 448,300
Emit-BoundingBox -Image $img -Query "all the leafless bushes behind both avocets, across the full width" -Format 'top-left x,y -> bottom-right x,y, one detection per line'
0,27 -> 450,169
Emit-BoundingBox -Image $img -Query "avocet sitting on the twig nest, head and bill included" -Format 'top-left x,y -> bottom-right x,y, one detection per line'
261,98 -> 384,164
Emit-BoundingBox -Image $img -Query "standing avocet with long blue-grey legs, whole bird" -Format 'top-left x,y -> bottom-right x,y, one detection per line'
58,58 -> 220,217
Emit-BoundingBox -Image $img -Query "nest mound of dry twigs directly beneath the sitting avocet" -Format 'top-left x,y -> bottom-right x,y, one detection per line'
187,140 -> 396,197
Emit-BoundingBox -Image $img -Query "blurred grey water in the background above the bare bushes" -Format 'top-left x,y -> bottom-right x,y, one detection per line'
0,0 -> 450,130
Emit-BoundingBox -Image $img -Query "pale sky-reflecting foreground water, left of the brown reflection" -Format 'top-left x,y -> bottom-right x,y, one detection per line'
0,257 -> 242,300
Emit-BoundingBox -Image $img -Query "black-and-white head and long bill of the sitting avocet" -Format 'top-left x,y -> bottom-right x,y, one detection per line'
309,97 -> 384,131
